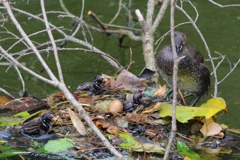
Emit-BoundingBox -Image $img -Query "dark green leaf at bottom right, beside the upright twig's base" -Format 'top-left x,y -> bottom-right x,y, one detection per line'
177,141 -> 200,160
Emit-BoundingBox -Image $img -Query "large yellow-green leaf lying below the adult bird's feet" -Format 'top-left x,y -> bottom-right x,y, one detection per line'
159,98 -> 226,123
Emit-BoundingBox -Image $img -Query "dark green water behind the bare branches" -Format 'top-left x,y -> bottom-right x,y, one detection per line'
0,0 -> 240,128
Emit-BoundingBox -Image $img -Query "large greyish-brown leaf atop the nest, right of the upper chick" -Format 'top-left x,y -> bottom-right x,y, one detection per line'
115,70 -> 147,90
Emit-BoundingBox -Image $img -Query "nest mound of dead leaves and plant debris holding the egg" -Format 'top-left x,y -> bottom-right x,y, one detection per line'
0,72 -> 240,159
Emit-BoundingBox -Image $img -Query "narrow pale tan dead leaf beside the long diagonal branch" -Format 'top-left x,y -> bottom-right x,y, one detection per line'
68,108 -> 87,136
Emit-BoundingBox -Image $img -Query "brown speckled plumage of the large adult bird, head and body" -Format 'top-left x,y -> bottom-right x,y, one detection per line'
156,31 -> 210,102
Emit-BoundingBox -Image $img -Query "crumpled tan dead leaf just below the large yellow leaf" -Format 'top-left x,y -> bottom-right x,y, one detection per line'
200,118 -> 222,138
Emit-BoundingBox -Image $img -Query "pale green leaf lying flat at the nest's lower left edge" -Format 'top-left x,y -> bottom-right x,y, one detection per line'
44,138 -> 75,153
